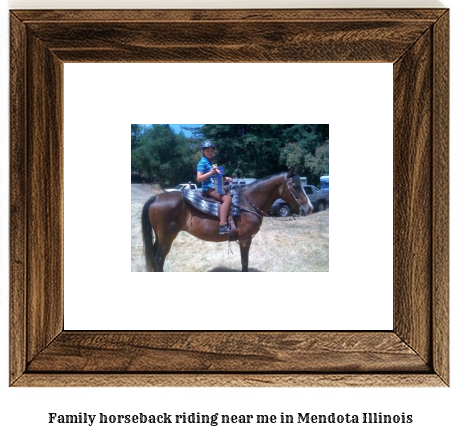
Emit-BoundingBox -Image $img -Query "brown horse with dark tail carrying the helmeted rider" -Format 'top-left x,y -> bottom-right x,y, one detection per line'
142,170 -> 313,272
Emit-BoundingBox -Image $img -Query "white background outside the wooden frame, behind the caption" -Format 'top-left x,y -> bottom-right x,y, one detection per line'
0,0 -> 461,436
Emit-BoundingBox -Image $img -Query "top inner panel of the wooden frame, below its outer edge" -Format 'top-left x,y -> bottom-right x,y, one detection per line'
24,21 -> 434,62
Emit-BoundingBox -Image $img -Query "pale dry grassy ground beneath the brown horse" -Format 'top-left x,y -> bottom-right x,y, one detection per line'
131,184 -> 330,272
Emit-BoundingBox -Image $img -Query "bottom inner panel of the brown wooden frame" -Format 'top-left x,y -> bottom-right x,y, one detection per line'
28,331 -> 430,373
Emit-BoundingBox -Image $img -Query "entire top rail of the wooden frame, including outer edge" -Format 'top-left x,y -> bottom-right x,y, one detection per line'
15,9 -> 448,62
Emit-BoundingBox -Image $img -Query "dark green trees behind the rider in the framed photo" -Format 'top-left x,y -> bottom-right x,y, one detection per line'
131,124 -> 329,186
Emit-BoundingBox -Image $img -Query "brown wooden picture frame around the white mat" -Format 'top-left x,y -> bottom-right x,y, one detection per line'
10,9 -> 449,386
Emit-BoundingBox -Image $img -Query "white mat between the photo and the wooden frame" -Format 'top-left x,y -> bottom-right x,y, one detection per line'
64,63 -> 393,330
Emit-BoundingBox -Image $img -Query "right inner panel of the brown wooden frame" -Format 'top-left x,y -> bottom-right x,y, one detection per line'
394,26 -> 432,362
